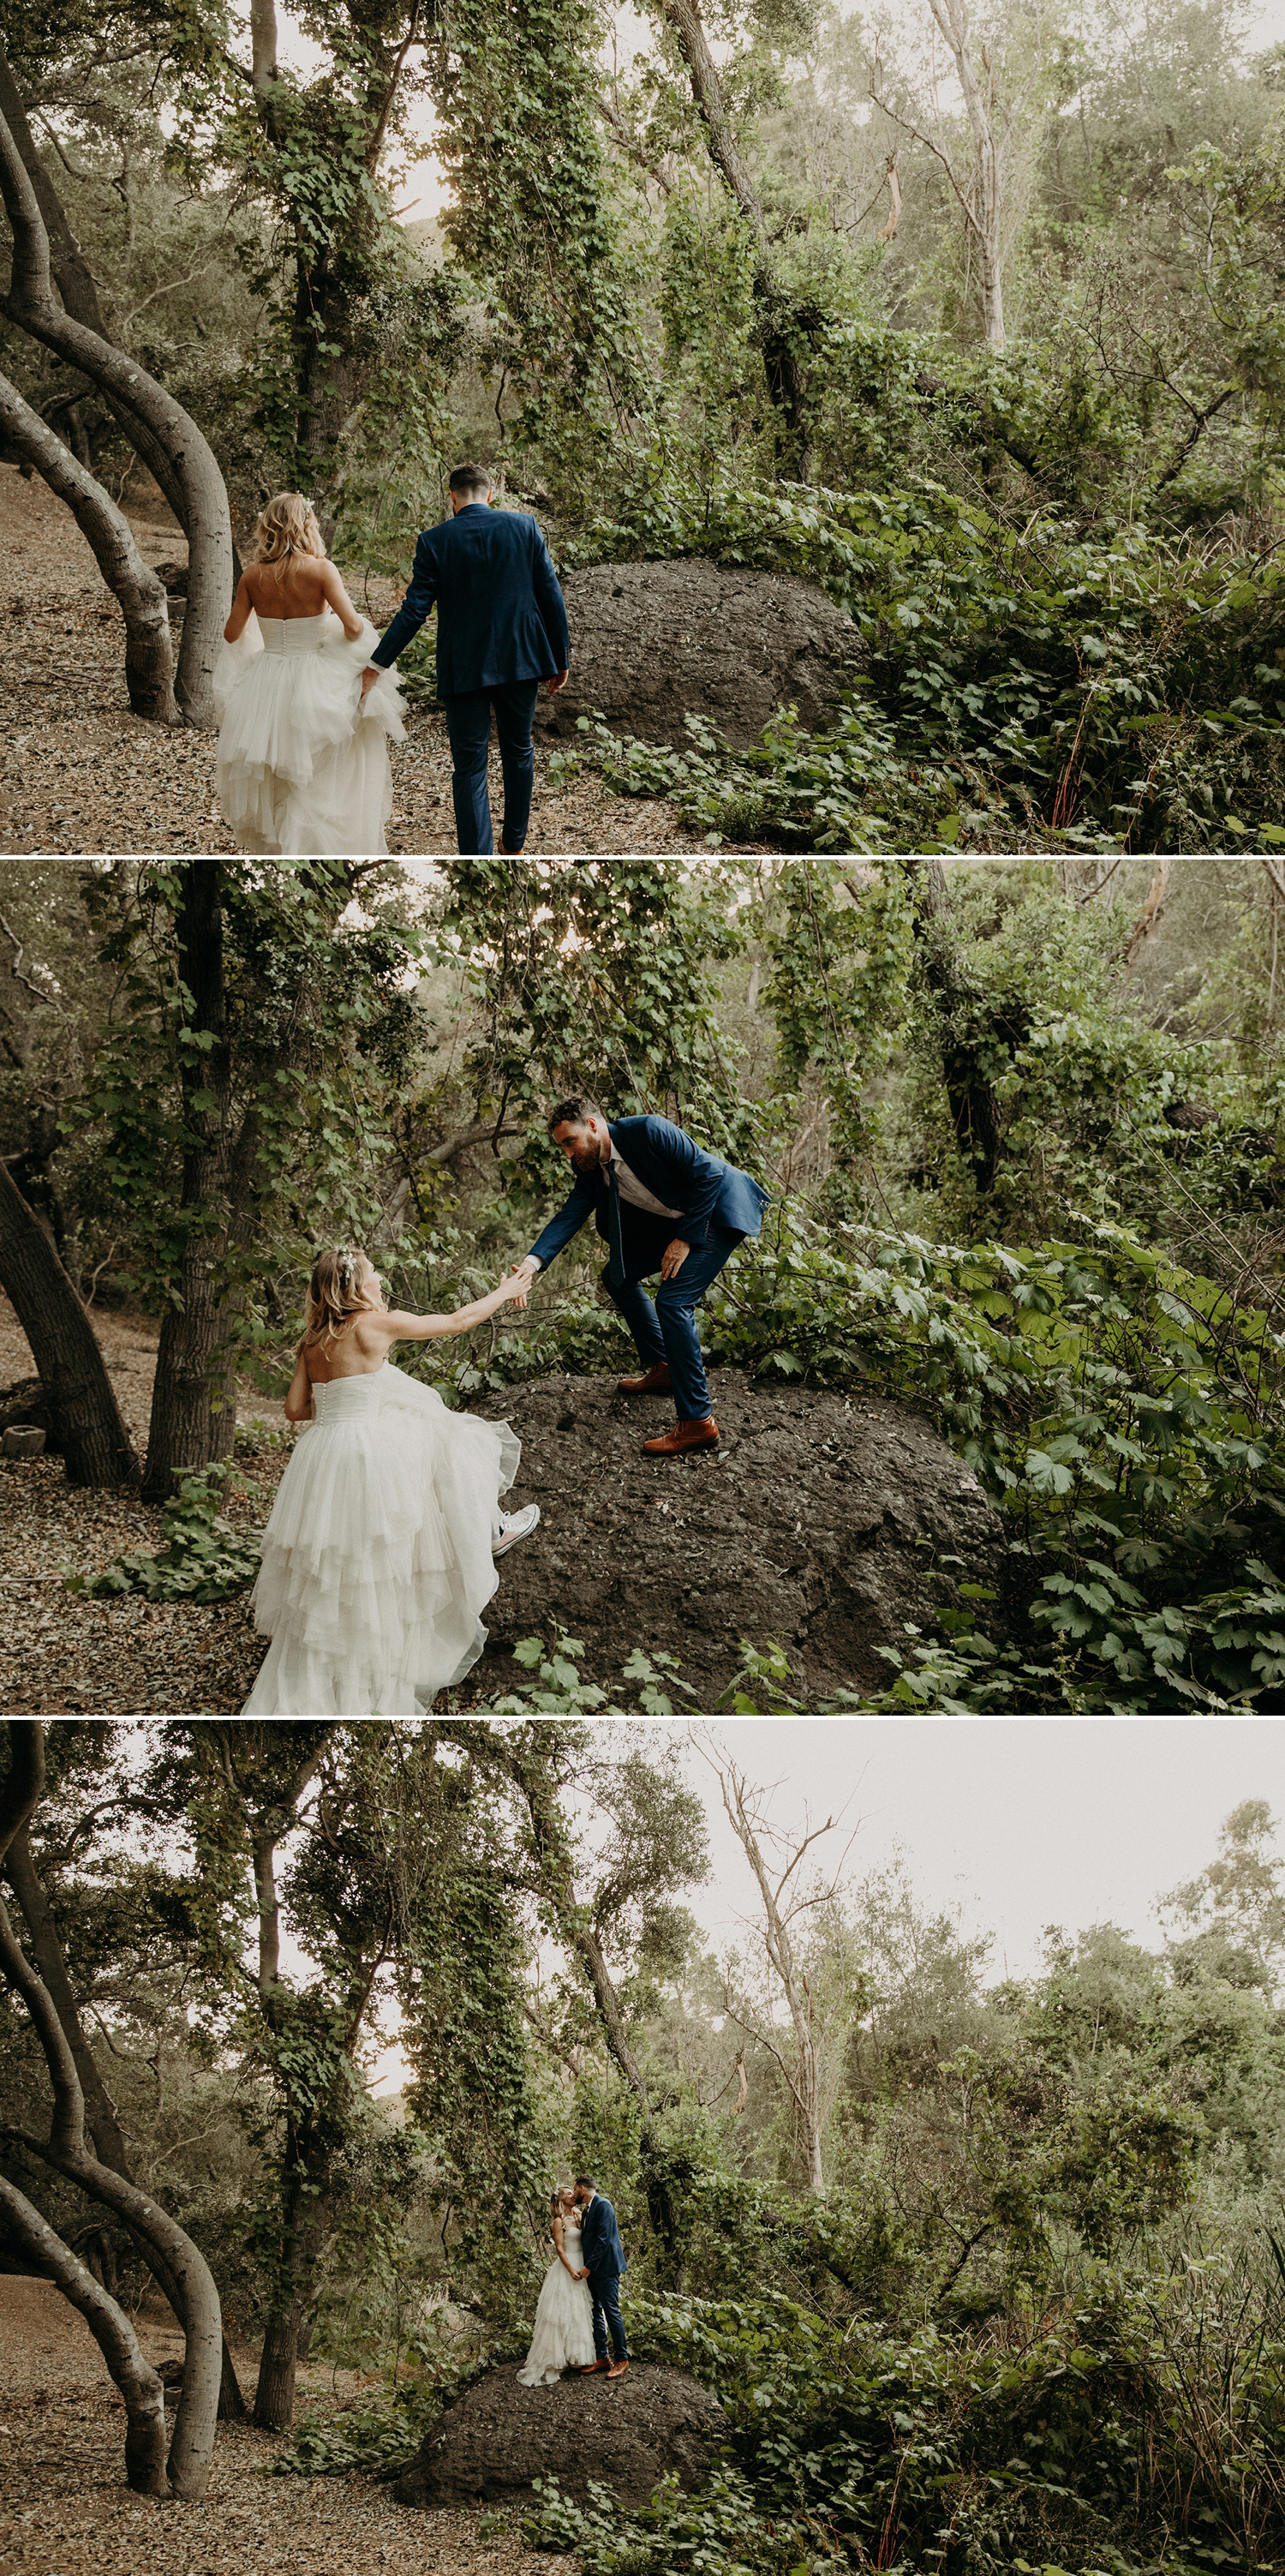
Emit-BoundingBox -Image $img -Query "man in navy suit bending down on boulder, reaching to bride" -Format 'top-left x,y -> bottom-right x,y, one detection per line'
512,1093 -> 768,1458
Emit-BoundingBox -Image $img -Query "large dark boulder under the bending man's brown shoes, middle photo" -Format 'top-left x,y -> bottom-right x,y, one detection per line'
479,1368 -> 1004,1708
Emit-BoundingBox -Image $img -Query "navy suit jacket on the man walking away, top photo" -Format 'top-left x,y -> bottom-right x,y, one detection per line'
371,500 -> 571,698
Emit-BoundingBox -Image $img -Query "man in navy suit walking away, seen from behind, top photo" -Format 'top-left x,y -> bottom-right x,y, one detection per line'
363,466 -> 571,858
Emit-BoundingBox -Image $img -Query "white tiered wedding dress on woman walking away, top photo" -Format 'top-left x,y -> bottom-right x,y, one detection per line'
213,608 -> 407,858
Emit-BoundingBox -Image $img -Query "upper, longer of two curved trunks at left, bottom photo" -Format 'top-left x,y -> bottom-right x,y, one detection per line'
0,1898 -> 224,2499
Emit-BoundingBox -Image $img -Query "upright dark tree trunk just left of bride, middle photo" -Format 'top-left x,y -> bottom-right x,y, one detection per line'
141,858 -> 237,1501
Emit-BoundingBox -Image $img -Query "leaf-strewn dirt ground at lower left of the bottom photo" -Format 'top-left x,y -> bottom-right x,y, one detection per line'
0,2274 -> 577,2576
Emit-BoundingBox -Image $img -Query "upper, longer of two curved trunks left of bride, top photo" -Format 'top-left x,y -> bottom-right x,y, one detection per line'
0,92 -> 232,727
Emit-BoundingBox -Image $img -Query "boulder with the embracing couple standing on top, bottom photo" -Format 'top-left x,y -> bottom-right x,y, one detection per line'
394,2363 -> 726,2507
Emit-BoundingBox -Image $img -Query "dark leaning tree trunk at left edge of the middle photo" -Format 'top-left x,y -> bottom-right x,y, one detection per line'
0,1162 -> 139,1483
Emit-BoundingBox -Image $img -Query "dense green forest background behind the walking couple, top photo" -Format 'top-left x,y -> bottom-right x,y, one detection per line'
0,0 -> 1285,853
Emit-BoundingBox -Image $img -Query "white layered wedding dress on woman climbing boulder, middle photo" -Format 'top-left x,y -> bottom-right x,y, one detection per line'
242,1360 -> 523,1718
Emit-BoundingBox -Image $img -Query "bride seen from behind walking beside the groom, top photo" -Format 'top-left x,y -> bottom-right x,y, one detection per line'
213,492 -> 407,858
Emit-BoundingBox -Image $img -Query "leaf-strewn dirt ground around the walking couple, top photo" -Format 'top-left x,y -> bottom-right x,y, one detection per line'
0,466 -> 703,858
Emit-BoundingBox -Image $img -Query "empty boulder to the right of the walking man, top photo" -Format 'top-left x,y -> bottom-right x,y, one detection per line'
535,556 -> 868,747
